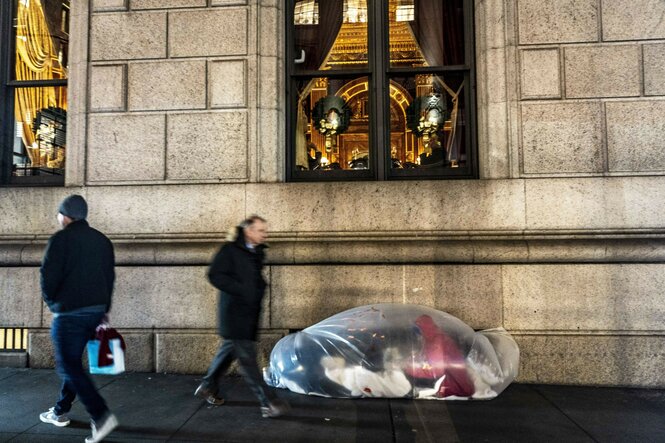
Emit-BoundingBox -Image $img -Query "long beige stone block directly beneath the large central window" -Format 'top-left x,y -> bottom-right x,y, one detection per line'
246,180 -> 524,233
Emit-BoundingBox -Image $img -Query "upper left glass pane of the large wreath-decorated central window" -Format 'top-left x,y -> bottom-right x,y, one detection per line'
293,0 -> 367,71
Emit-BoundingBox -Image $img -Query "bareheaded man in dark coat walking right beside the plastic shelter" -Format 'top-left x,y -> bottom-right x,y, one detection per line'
194,215 -> 288,417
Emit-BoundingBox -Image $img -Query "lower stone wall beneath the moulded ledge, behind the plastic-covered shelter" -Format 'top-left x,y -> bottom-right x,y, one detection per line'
5,264 -> 665,387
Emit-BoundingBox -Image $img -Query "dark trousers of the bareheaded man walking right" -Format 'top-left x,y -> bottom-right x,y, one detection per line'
202,339 -> 274,406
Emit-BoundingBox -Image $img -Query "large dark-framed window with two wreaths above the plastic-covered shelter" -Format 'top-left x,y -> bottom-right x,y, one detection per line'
286,0 -> 477,180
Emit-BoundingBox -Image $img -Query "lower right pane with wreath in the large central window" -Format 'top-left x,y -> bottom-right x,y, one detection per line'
390,74 -> 466,169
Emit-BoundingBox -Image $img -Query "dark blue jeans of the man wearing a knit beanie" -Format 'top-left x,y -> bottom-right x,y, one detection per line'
51,312 -> 108,421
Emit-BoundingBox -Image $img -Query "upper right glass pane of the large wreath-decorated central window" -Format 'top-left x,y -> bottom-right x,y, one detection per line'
388,0 -> 464,68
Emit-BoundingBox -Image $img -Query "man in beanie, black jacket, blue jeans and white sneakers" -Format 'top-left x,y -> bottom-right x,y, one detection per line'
39,195 -> 118,443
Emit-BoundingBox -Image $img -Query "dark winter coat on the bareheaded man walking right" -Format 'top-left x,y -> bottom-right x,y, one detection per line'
208,231 -> 266,341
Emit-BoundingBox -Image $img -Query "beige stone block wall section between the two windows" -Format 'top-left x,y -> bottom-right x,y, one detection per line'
84,0 -> 284,185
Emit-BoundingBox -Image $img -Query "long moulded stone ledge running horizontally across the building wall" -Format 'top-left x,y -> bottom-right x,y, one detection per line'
0,238 -> 665,267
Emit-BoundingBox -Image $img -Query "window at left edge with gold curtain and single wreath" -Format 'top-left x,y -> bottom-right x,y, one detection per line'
0,0 -> 70,185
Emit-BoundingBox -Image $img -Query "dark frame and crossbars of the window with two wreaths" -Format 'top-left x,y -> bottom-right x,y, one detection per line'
284,0 -> 479,182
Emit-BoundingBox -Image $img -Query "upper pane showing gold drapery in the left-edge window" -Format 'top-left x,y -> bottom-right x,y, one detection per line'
14,0 -> 69,81
